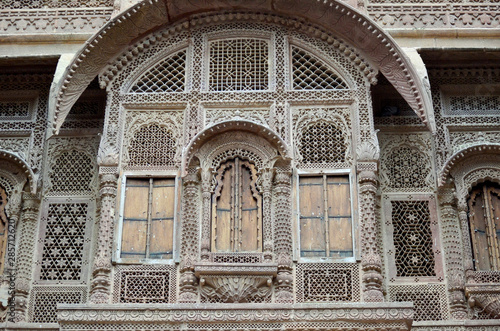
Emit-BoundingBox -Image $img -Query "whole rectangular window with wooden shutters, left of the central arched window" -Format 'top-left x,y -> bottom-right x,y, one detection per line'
120,178 -> 175,259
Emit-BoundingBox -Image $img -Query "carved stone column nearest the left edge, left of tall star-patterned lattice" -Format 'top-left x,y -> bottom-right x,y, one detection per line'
11,192 -> 40,322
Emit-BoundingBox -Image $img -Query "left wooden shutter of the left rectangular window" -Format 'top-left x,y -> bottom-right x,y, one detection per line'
121,178 -> 149,258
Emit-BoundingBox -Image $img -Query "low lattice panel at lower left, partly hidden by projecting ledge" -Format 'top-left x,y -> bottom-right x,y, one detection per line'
28,286 -> 87,323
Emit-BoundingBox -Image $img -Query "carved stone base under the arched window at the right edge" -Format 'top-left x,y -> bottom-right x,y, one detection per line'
465,284 -> 500,319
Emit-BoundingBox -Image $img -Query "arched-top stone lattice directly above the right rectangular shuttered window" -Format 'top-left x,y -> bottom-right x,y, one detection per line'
299,121 -> 347,164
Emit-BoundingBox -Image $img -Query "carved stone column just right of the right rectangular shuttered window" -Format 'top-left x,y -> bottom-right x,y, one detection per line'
358,162 -> 384,302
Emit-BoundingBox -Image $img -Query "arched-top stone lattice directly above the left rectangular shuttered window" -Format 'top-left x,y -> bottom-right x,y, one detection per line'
129,124 -> 177,167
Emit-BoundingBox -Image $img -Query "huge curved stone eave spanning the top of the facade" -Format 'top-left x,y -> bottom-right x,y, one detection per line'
49,0 -> 435,133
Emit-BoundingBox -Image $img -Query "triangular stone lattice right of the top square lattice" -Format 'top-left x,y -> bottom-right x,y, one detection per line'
292,47 -> 348,90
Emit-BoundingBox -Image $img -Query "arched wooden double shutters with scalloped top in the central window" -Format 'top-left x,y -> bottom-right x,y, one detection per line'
212,157 -> 262,252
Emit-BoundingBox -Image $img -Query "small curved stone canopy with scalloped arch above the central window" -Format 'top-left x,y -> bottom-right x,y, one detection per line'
182,121 -> 290,174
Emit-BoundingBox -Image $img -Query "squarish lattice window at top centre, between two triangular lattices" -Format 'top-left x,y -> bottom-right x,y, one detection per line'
208,38 -> 270,91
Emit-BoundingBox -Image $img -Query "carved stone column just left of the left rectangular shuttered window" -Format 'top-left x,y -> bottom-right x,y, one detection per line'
90,172 -> 118,304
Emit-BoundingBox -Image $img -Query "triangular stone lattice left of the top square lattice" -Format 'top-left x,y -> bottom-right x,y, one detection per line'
131,50 -> 186,93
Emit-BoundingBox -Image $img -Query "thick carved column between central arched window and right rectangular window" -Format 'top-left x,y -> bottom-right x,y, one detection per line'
274,168 -> 293,303
